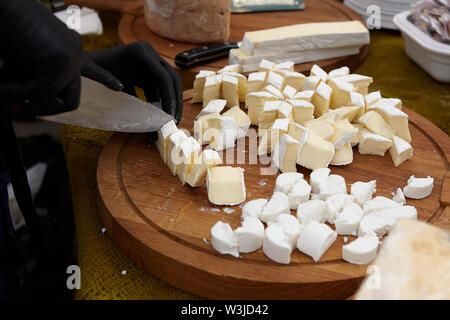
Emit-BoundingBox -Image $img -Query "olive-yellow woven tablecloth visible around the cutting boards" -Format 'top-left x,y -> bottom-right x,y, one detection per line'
70,6 -> 450,299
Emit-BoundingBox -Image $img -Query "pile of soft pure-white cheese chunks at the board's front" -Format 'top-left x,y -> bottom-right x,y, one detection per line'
211,168 -> 433,264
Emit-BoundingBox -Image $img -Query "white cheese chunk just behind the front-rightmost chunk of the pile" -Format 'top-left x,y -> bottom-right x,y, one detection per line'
358,211 -> 396,239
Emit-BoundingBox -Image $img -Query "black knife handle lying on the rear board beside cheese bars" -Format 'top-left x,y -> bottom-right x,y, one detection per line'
175,42 -> 239,69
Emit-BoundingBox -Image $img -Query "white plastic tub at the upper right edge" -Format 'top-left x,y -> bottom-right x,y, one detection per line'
394,11 -> 450,82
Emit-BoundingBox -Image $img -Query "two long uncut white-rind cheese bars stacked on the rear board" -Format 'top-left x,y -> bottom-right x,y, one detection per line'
229,21 -> 370,72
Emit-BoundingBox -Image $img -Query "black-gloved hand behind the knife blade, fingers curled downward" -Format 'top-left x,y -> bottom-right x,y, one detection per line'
81,41 -> 183,122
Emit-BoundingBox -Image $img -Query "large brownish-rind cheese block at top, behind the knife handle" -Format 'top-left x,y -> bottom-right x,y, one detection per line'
144,0 -> 230,43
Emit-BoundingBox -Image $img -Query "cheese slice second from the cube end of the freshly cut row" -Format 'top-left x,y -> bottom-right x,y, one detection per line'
176,137 -> 201,185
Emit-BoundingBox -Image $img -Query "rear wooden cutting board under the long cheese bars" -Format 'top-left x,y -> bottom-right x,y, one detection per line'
119,0 -> 369,88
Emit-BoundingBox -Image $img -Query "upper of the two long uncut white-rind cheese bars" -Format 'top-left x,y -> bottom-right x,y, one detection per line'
240,20 -> 369,56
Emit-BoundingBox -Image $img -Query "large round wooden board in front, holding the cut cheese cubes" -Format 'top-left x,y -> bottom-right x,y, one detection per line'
97,91 -> 450,299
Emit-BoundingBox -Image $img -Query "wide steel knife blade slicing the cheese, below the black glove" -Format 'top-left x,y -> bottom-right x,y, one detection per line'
40,77 -> 174,133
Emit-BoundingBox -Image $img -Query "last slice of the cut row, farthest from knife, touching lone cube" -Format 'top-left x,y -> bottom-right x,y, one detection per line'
186,149 -> 222,187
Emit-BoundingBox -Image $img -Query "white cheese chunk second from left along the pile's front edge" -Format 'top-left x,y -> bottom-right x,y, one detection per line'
234,217 -> 264,253
